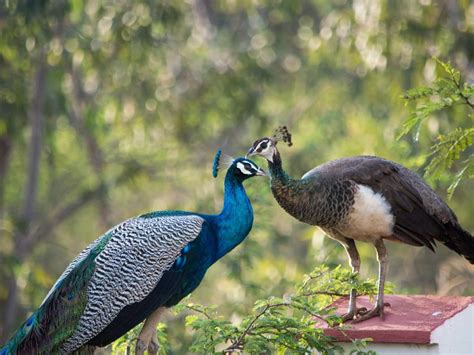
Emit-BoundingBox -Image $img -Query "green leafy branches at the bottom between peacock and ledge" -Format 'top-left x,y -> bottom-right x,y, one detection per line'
131,266 -> 392,355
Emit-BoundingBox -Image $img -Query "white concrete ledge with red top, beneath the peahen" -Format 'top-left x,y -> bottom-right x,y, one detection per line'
318,295 -> 474,354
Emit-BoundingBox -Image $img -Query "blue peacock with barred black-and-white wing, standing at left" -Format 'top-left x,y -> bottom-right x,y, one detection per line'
0,150 -> 265,355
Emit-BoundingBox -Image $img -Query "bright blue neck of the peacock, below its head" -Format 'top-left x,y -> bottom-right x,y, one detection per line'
214,171 -> 253,259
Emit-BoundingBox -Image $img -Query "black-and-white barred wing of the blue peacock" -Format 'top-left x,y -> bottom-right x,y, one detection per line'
58,215 -> 204,352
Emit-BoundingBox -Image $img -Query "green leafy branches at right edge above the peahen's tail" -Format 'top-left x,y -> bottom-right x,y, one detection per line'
398,59 -> 474,197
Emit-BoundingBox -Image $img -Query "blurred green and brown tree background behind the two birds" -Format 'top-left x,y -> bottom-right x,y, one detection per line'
0,0 -> 474,353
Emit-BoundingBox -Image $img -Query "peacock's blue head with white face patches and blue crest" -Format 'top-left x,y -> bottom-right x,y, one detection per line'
212,149 -> 267,181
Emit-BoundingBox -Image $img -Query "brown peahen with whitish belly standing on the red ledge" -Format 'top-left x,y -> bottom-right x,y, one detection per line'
247,127 -> 474,322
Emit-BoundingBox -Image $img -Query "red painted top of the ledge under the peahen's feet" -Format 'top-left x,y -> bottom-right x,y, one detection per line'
317,295 -> 474,344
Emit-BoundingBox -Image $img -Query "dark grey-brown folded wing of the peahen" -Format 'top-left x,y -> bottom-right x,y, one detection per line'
303,156 -> 457,249
